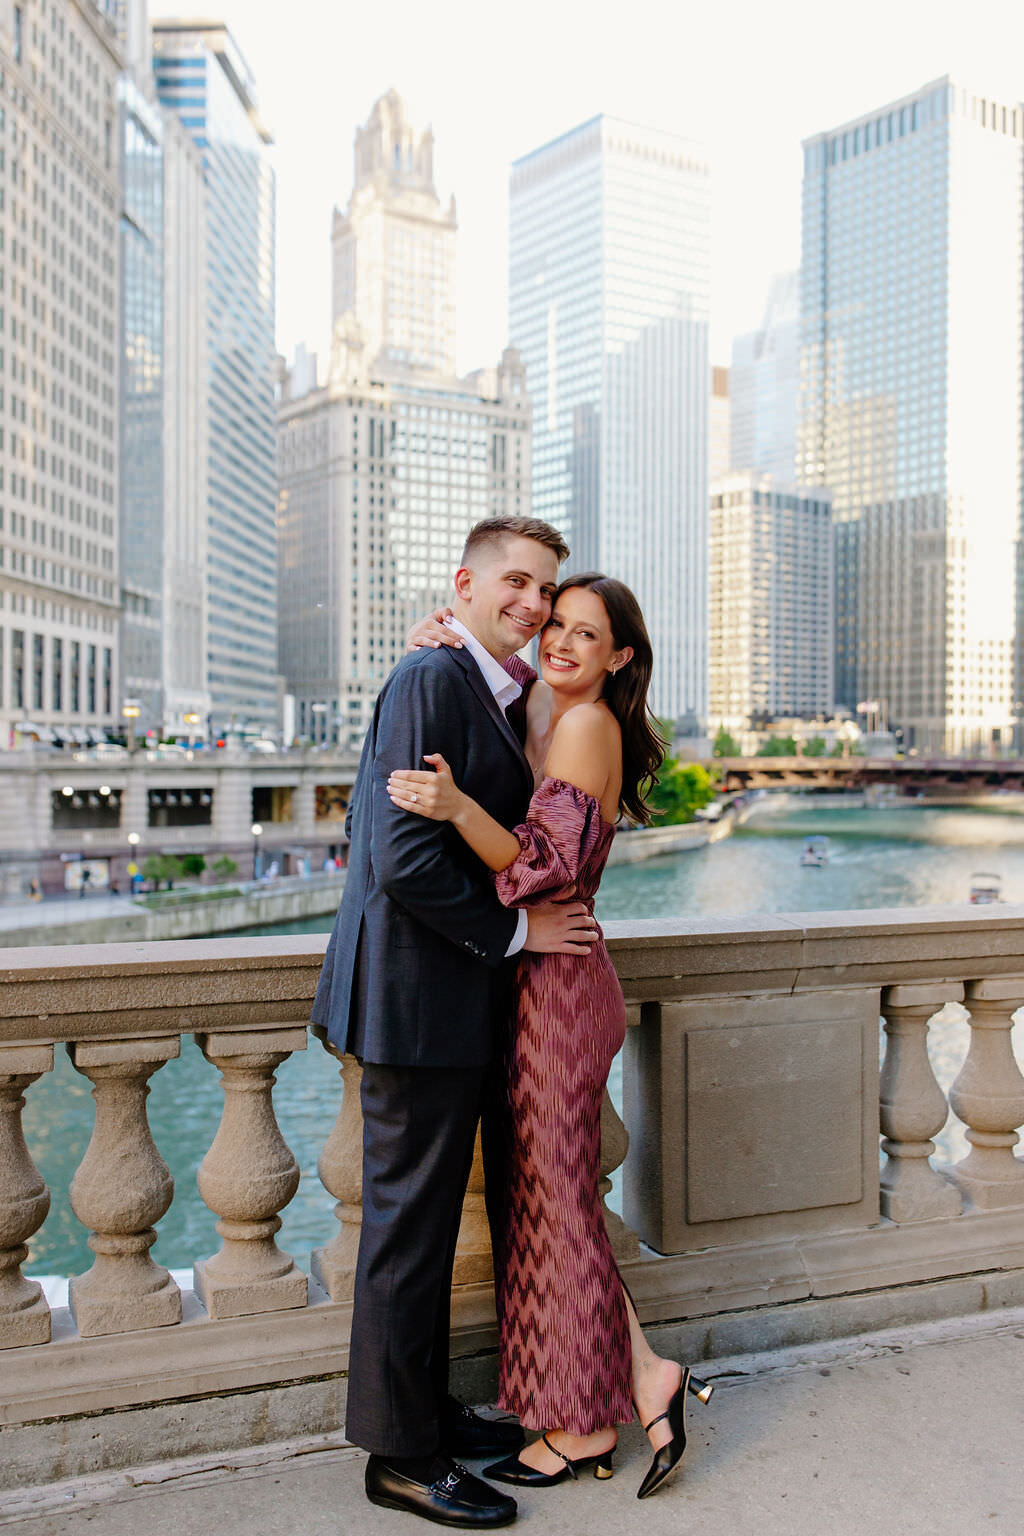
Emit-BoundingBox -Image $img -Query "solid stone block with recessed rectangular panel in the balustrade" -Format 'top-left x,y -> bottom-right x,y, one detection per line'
623,989 -> 878,1253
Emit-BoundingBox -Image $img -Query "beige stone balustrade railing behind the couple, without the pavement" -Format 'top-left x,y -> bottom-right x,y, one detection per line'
0,908 -> 1024,1485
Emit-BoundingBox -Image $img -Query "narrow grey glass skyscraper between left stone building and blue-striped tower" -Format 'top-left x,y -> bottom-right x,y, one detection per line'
115,0 -> 210,736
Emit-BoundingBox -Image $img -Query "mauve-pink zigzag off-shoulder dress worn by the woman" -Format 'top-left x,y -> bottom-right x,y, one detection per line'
494,777 -> 633,1435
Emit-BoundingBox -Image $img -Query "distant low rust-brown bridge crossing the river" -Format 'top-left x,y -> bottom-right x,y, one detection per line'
718,756 -> 1024,799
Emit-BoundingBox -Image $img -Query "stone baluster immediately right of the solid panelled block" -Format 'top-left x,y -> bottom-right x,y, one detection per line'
880,985 -> 964,1221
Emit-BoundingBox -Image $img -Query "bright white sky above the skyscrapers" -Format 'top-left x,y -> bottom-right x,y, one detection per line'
158,0 -> 1024,372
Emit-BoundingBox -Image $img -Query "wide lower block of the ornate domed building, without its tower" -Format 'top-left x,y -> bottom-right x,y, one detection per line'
278,335 -> 530,748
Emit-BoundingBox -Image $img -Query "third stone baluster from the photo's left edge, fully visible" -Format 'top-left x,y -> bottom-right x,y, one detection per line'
193,1028 -> 309,1318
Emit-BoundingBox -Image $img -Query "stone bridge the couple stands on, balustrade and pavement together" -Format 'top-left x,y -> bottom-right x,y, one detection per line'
0,906 -> 1024,1536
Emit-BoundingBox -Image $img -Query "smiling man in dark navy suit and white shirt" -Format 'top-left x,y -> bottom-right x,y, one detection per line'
313,518 -> 594,1528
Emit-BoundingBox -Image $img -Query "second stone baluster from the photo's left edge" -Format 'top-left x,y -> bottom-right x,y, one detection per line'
68,1035 -> 181,1336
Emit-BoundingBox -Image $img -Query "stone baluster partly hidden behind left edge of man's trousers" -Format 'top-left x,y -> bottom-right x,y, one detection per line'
310,1025 -> 362,1301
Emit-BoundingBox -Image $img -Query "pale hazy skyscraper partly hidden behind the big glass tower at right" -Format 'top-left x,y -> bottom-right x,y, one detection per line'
729,272 -> 800,485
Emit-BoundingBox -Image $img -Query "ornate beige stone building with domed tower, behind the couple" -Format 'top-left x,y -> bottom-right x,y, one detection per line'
278,92 -> 530,748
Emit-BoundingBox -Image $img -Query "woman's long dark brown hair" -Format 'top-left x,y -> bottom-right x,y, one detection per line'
553,571 -> 668,826
